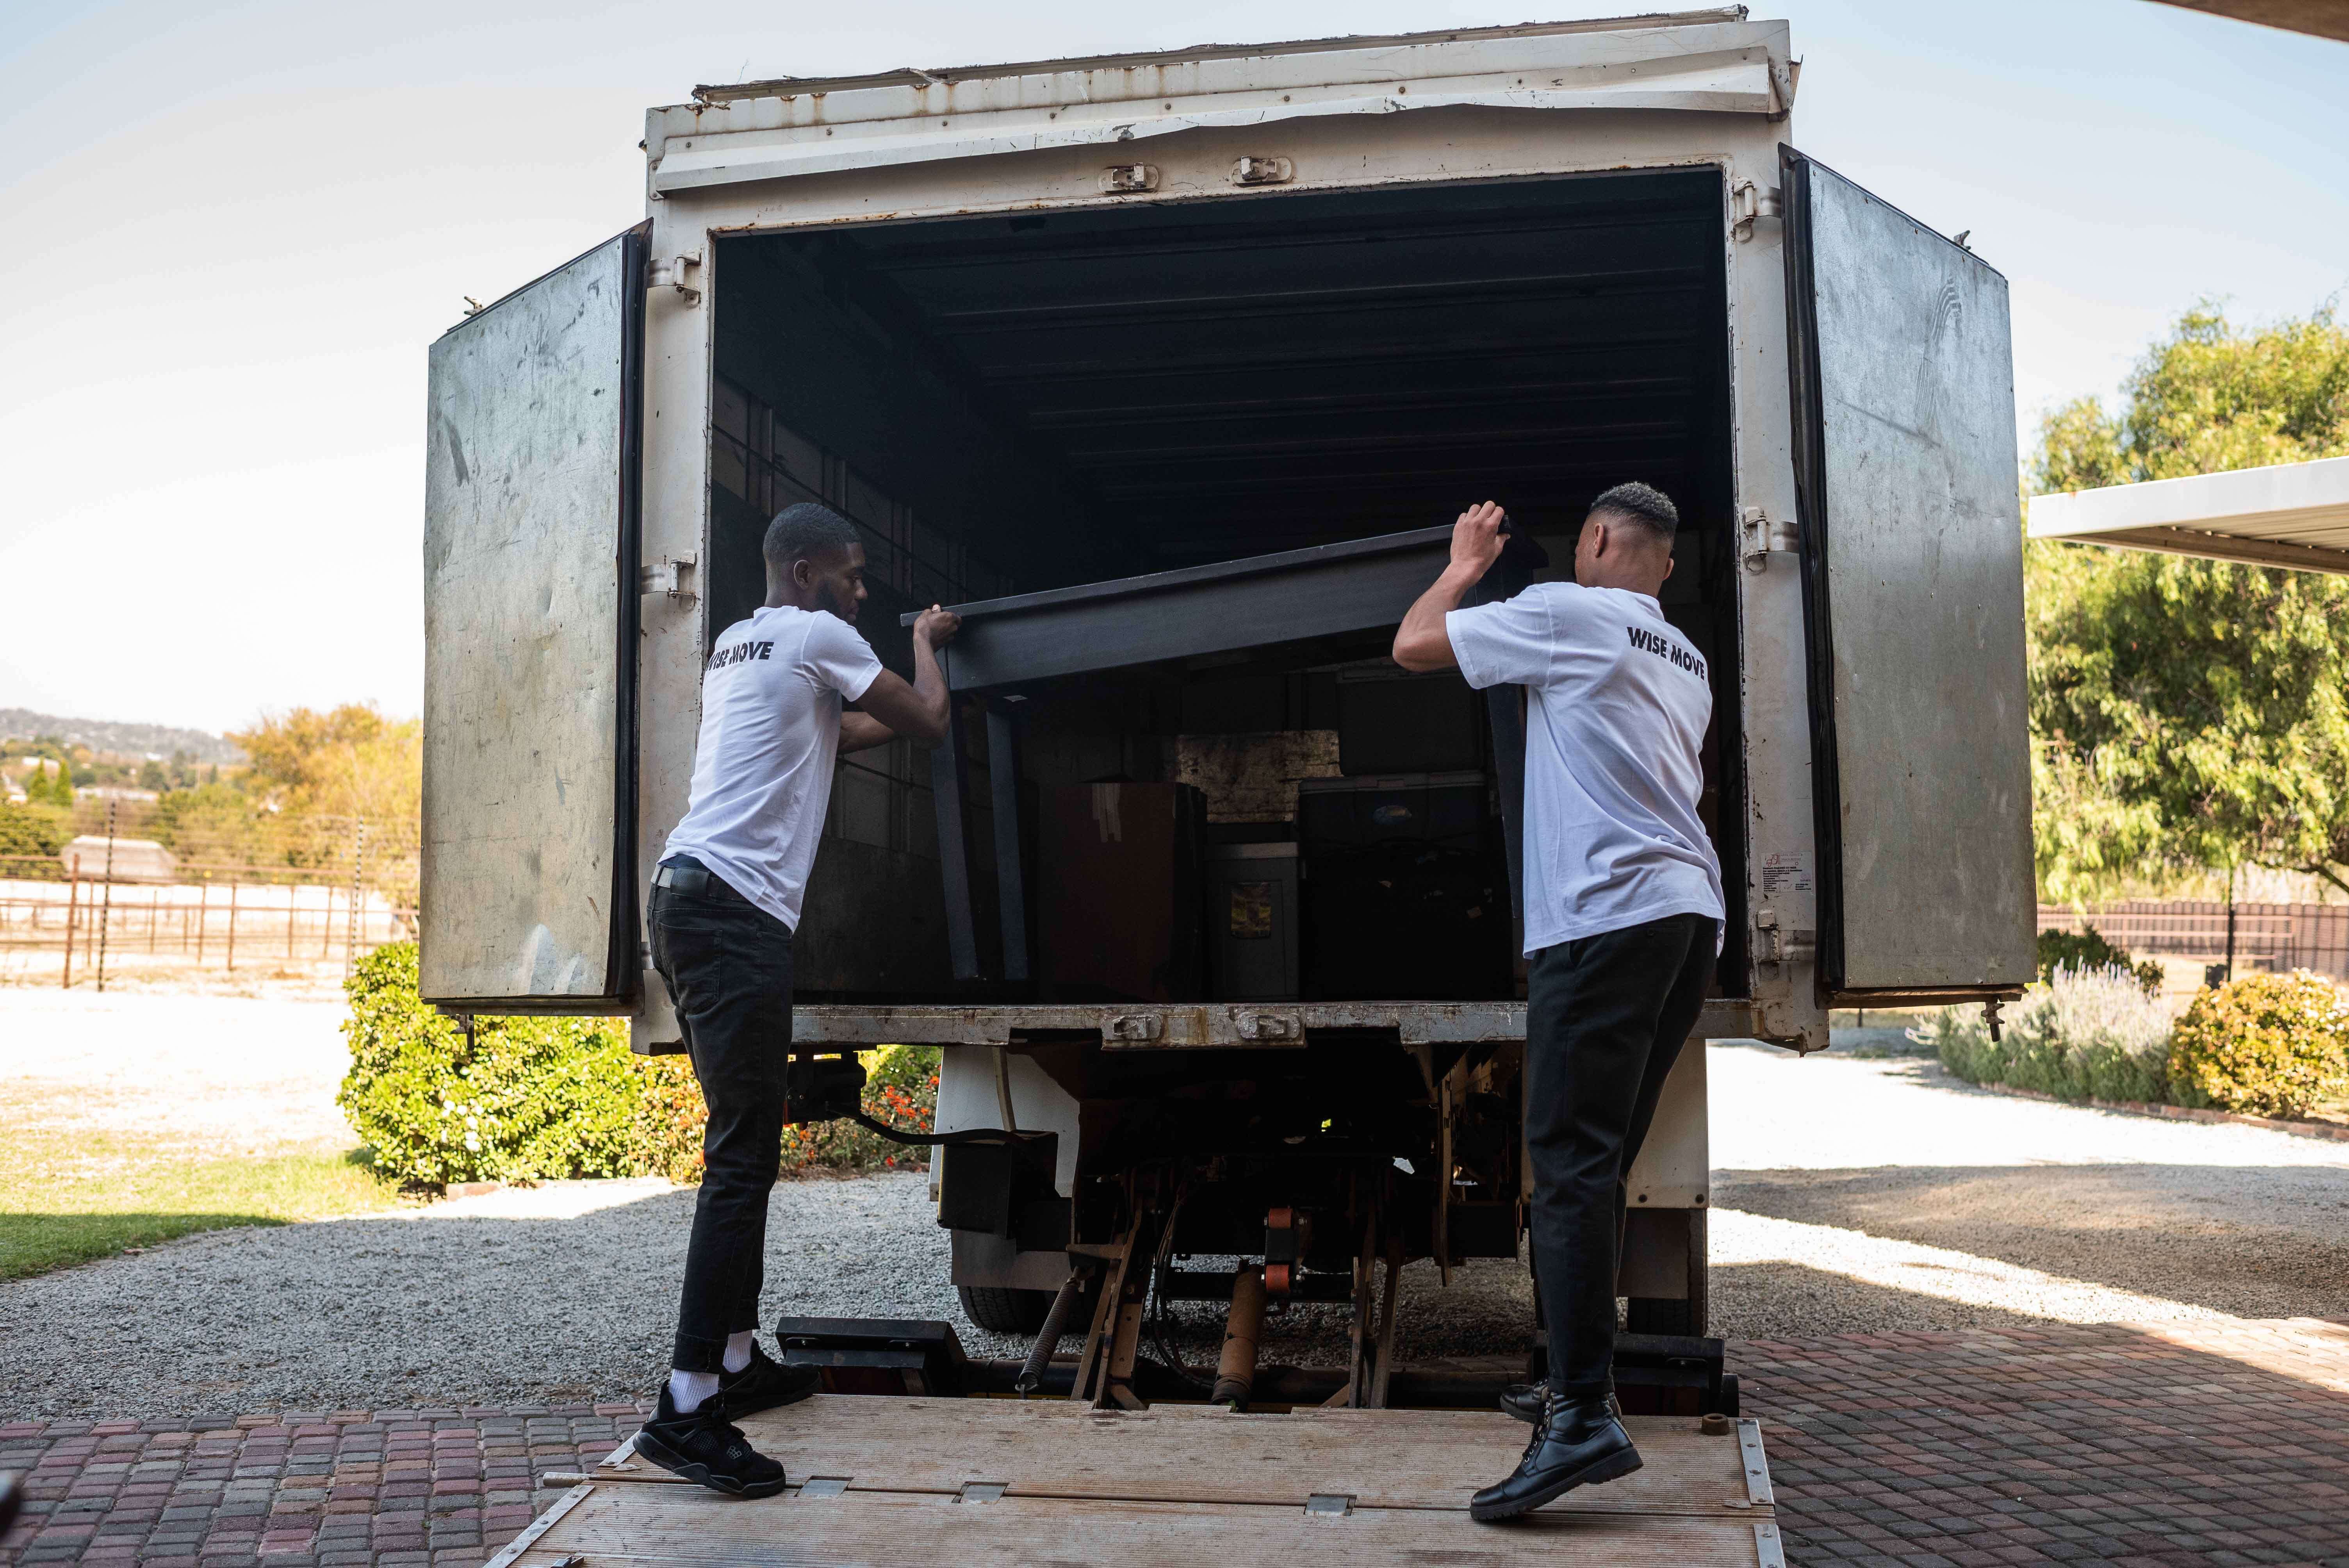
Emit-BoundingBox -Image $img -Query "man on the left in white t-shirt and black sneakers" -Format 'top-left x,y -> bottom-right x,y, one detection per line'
636,502 -> 961,1498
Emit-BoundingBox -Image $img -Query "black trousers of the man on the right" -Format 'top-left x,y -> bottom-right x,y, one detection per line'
1524,916 -> 1715,1399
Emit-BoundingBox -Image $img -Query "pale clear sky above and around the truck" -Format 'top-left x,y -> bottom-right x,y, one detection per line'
0,0 -> 2349,730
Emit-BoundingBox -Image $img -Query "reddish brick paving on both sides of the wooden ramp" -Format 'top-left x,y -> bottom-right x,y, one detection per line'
0,1319 -> 2349,1568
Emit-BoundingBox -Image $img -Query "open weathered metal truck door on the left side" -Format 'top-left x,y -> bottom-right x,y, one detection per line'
418,225 -> 648,1012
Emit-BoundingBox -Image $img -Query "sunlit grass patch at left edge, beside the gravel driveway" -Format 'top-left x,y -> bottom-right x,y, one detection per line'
0,1122 -> 399,1279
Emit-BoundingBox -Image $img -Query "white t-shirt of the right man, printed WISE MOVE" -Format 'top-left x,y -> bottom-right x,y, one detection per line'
1445,582 -> 1722,955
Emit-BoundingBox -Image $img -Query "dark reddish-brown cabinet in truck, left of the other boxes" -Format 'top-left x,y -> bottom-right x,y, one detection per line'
1036,784 -> 1207,1002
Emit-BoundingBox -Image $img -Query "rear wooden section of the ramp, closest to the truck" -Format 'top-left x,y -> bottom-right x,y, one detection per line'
604,1394 -> 1750,1516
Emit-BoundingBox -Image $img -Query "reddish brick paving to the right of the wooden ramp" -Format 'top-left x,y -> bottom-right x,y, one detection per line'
1736,1319 -> 2349,1568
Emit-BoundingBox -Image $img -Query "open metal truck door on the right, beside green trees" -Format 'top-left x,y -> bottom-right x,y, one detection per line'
1780,148 -> 2037,1000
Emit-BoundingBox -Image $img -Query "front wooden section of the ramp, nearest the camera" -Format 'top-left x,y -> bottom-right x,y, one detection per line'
519,1483 -> 1776,1568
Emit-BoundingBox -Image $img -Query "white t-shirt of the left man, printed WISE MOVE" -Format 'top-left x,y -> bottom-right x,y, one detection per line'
663,606 -> 881,932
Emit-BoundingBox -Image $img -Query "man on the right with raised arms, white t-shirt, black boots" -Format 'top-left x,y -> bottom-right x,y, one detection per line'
1395,483 -> 1722,1519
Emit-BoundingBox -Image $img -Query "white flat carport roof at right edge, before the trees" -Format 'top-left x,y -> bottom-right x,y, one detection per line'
2032,458 -> 2349,573
